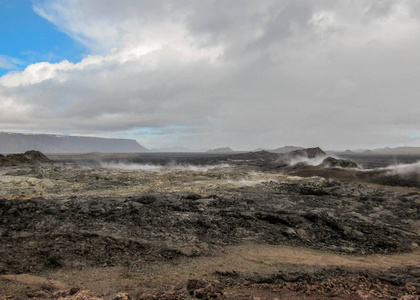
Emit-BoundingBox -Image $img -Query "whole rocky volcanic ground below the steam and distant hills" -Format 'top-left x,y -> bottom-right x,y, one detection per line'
0,151 -> 420,299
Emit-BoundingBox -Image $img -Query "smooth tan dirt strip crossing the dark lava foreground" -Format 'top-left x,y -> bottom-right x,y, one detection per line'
45,245 -> 420,296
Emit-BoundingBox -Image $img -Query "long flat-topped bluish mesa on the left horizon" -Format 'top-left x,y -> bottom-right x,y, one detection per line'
0,132 -> 148,153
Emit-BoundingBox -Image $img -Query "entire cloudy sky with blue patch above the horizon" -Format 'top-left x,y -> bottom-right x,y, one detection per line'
0,0 -> 420,150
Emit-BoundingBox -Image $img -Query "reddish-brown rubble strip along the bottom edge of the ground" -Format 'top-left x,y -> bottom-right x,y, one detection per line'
3,274 -> 419,300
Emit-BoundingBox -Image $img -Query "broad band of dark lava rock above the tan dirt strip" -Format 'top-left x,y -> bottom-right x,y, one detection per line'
0,174 -> 420,272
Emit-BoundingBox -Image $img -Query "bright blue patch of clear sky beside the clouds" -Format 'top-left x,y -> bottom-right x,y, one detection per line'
0,0 -> 86,76
